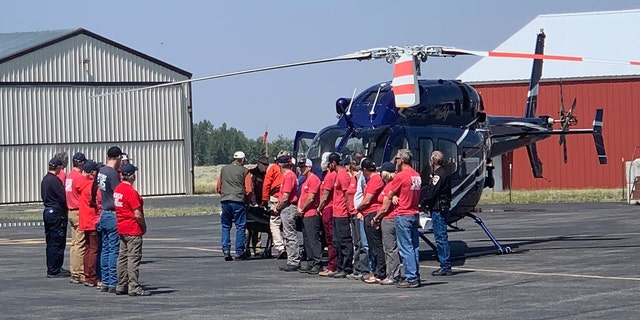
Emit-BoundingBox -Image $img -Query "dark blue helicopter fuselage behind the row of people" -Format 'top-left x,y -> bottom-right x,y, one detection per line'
306,80 -> 548,223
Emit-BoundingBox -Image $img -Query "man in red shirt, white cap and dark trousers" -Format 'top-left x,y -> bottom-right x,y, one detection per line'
298,159 -> 322,274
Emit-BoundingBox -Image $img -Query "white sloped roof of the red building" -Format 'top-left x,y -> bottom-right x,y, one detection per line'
458,9 -> 640,82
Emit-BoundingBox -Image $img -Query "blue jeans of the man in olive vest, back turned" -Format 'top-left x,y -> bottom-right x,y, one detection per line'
220,201 -> 247,257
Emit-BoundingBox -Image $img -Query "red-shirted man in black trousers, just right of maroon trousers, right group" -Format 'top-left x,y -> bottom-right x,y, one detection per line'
329,152 -> 353,278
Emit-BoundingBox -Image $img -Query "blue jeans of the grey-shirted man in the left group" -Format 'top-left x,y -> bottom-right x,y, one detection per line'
98,211 -> 120,288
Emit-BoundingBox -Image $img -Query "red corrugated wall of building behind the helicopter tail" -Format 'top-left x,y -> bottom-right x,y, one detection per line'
473,79 -> 640,189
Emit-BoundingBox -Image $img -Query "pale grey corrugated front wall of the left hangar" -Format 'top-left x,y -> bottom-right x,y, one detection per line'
0,34 -> 193,203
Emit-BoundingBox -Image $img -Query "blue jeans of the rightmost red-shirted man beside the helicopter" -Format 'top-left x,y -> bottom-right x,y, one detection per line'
394,213 -> 420,282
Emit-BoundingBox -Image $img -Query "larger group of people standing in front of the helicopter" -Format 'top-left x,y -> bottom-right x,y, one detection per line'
217,149 -> 453,288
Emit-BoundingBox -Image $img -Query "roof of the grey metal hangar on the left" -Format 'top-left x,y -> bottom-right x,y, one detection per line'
0,28 -> 191,78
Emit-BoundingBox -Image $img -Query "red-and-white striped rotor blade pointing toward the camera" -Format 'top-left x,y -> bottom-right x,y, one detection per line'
391,54 -> 420,109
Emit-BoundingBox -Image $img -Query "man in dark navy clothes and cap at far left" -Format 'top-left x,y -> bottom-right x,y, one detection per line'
40,158 -> 71,278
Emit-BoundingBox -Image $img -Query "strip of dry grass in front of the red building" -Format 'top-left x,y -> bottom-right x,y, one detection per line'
479,189 -> 624,204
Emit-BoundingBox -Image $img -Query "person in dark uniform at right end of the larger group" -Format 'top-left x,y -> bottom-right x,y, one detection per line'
421,150 -> 453,276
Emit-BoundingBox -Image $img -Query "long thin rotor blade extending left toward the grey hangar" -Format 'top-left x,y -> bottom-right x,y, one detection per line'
92,51 -> 371,98
